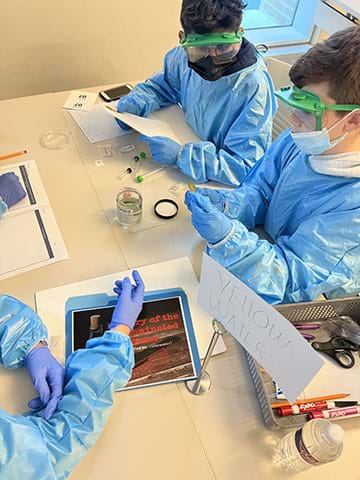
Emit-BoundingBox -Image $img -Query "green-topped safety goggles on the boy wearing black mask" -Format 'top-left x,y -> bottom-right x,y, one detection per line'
179,29 -> 244,64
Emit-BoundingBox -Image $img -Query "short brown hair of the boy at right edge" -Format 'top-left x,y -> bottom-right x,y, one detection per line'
290,26 -> 360,105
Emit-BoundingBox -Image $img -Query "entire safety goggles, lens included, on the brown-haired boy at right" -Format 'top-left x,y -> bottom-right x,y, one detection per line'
275,86 -> 360,131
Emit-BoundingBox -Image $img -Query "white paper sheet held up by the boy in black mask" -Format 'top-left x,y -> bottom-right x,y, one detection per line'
104,105 -> 181,143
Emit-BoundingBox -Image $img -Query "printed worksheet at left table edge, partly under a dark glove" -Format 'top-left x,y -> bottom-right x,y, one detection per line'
0,160 -> 69,280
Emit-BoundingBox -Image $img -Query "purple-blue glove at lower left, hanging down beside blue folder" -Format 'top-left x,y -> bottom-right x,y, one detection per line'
24,345 -> 65,420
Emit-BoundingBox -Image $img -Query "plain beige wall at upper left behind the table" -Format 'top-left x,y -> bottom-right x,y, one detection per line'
0,0 -> 181,99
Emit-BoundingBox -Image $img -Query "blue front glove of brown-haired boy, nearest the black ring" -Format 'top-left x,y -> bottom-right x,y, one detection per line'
185,192 -> 232,244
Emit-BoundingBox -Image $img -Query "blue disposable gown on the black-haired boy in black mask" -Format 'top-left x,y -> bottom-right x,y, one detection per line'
121,47 -> 277,186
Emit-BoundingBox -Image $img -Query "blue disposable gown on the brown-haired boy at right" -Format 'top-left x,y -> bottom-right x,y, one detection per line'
208,131 -> 360,304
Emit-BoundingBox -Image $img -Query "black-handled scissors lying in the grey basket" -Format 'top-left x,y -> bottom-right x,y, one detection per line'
311,337 -> 360,368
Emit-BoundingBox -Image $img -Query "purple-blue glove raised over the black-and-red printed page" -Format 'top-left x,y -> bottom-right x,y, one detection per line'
109,270 -> 145,330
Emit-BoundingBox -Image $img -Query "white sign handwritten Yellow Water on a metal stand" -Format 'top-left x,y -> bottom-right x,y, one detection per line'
198,254 -> 324,402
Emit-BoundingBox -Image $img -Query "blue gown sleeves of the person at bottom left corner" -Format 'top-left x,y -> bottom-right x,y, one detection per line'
0,295 -> 133,480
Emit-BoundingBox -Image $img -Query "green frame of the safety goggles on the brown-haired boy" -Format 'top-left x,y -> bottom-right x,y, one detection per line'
275,86 -> 360,130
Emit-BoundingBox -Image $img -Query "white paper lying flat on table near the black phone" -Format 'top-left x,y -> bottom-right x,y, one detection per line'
69,102 -> 129,143
